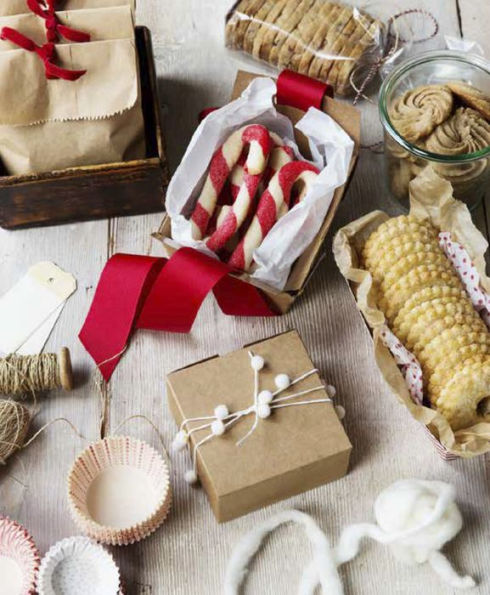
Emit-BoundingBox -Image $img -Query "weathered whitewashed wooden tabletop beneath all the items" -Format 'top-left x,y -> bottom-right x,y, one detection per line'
0,0 -> 490,595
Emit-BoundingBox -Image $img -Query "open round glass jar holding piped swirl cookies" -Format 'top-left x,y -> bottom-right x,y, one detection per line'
379,50 -> 490,208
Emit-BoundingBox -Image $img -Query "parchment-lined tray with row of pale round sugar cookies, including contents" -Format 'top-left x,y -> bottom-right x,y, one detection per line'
334,167 -> 490,460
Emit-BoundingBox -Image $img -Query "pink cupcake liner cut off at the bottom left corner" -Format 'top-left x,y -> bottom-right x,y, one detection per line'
0,516 -> 40,595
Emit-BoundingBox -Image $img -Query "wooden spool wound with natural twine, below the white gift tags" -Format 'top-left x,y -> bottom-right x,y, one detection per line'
0,347 -> 73,395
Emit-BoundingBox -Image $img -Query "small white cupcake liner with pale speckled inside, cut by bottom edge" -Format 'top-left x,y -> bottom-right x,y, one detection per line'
37,537 -> 121,595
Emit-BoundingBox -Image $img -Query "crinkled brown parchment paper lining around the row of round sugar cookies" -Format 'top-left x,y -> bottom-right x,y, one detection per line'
333,167 -> 490,458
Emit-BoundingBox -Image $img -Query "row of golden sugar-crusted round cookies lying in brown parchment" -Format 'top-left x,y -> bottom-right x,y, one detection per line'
362,216 -> 490,430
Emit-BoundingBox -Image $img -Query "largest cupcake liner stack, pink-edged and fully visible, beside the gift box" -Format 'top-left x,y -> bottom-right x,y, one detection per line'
68,436 -> 172,545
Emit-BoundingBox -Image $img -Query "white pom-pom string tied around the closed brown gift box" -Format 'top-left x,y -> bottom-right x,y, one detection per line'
172,351 -> 335,484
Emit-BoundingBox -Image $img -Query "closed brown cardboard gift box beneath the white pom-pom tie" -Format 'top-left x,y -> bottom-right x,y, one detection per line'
167,331 -> 352,521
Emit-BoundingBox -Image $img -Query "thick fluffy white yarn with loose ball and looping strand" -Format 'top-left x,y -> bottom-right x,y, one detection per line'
225,479 -> 475,595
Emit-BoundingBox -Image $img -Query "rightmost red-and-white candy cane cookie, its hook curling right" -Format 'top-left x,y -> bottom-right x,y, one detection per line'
229,161 -> 319,271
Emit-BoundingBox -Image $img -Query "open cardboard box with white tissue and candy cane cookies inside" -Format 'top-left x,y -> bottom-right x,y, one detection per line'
155,72 -> 360,313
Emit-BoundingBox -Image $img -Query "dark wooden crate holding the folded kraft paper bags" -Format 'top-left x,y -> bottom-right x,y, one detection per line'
0,27 -> 168,229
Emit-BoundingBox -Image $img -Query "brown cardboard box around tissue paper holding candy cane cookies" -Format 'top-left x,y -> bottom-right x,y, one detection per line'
154,71 -> 361,314
